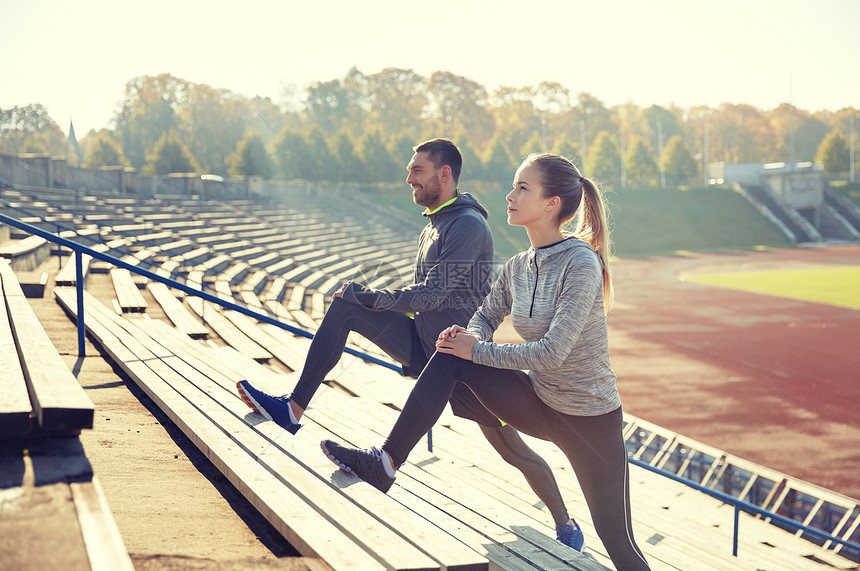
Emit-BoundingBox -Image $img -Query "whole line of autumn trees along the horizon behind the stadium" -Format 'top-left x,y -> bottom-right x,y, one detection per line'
0,68 -> 860,187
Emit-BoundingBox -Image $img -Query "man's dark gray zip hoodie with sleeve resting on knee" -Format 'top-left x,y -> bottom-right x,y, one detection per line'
343,193 -> 493,362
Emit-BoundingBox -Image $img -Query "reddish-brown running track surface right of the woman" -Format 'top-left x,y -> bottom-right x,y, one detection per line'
609,245 -> 860,498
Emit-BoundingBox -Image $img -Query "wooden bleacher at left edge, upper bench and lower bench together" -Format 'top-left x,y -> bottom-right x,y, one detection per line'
0,260 -> 133,570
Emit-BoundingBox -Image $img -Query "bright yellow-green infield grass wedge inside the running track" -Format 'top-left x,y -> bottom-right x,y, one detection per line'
686,267 -> 860,309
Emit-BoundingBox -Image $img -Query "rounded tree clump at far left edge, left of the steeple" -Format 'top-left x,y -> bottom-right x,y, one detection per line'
0,103 -> 71,156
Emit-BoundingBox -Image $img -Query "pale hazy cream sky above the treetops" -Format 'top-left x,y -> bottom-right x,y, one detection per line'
0,0 -> 860,137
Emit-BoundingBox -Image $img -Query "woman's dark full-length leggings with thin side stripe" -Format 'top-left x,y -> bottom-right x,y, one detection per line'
382,353 -> 649,570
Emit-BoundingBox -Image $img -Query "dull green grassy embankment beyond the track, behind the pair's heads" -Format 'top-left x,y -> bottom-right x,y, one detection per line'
358,184 -> 791,259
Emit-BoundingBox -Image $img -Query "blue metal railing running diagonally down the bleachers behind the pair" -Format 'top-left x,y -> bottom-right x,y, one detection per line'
0,194 -> 860,557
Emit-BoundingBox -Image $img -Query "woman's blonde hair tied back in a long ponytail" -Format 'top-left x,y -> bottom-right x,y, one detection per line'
521,153 -> 613,312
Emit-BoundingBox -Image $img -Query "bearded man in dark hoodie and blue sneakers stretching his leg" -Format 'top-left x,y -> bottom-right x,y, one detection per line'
238,139 -> 582,550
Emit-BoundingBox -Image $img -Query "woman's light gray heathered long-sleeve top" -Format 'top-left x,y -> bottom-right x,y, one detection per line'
468,238 -> 621,416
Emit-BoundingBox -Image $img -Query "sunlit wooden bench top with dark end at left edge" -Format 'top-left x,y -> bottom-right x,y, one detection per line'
0,260 -> 94,435
